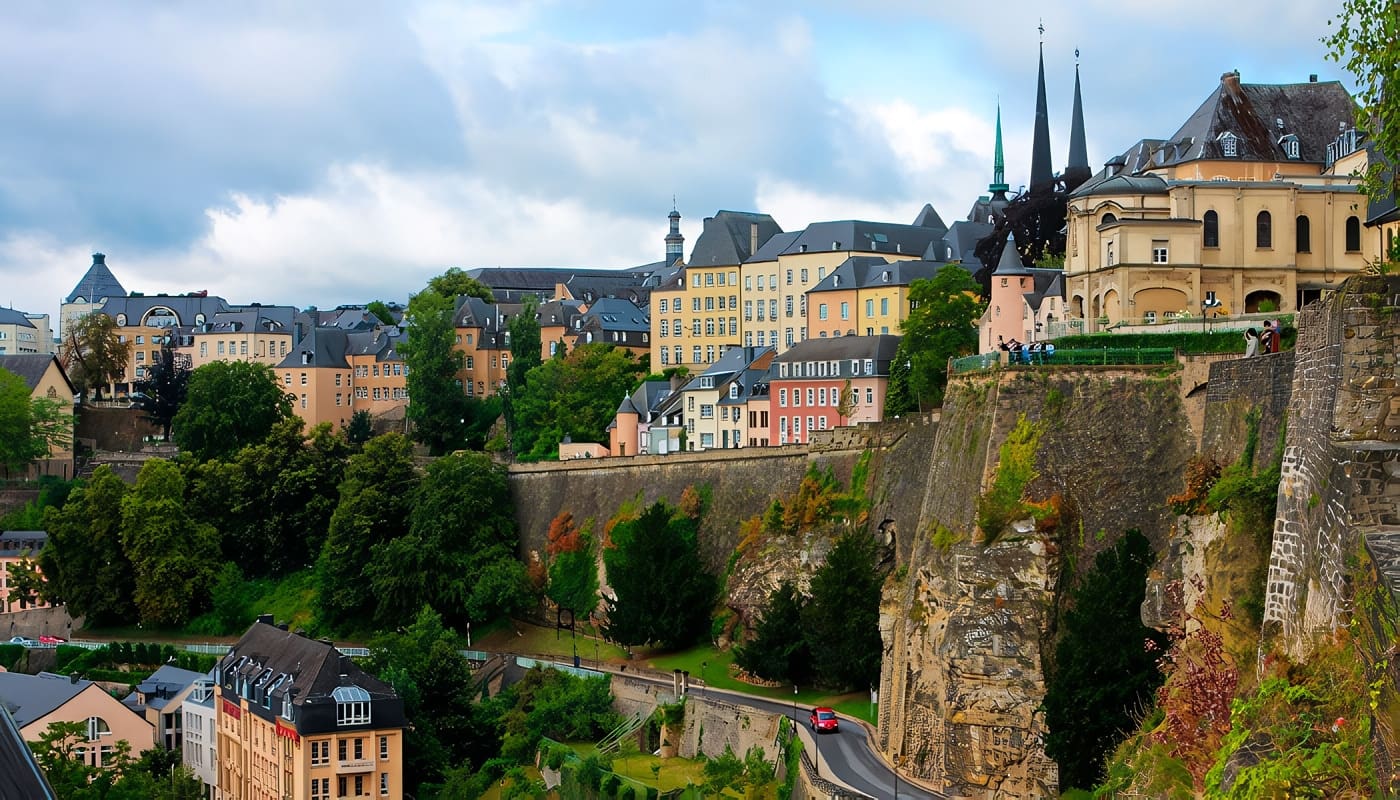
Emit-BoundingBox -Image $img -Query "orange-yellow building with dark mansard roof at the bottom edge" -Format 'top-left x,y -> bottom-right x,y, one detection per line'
214,616 -> 407,800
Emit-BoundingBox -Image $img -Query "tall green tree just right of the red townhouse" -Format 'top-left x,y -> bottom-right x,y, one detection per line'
896,263 -> 987,408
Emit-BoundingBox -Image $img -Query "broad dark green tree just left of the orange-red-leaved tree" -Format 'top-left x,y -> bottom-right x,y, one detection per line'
364,453 -> 525,626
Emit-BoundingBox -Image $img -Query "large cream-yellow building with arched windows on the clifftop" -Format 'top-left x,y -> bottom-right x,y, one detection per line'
1064,73 -> 1379,332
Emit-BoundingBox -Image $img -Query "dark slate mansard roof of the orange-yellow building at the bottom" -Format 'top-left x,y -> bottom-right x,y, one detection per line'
214,618 -> 406,734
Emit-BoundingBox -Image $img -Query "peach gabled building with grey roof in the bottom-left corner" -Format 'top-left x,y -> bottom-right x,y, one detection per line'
0,673 -> 155,768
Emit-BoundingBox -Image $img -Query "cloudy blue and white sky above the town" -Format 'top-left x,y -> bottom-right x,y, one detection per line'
0,0 -> 1350,325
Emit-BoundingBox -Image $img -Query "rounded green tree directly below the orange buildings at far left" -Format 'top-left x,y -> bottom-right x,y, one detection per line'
172,361 -> 291,461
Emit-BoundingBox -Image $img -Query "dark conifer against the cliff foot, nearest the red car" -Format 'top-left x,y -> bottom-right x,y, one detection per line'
802,531 -> 883,689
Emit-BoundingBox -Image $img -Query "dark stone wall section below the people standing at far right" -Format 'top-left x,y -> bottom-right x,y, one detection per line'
1201,350 -> 1295,469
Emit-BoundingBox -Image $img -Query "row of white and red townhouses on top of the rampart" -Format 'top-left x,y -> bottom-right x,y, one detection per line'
610,333 -> 899,457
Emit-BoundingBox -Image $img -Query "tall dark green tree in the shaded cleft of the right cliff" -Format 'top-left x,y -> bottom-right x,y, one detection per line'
1044,531 -> 1166,789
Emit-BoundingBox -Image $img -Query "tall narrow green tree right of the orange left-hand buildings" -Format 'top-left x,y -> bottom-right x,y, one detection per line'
399,291 -> 466,455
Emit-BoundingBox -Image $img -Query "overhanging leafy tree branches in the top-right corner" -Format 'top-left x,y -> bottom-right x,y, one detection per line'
1322,0 -> 1400,200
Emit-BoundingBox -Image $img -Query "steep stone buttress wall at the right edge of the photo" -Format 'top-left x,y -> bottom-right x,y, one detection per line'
1264,276 -> 1400,653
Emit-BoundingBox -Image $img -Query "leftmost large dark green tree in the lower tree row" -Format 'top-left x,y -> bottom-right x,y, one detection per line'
39,464 -> 136,625
